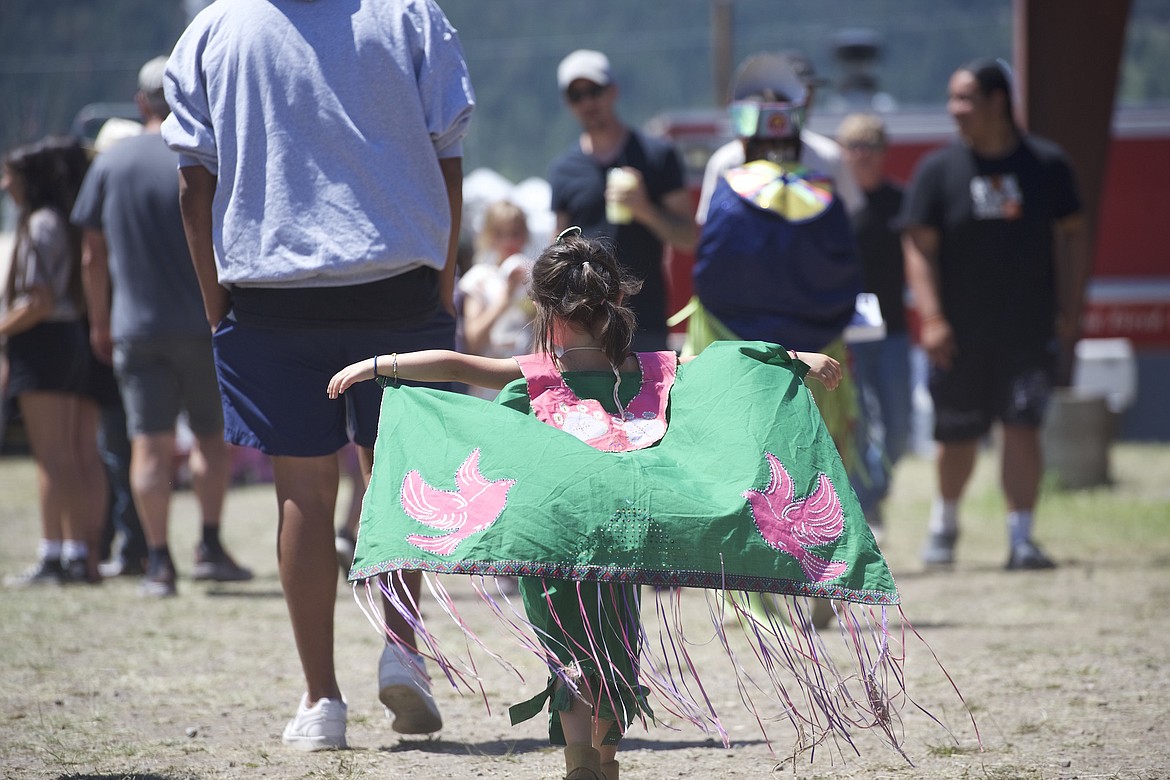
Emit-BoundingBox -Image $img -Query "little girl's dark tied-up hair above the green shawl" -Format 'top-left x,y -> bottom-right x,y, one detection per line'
531,234 -> 642,366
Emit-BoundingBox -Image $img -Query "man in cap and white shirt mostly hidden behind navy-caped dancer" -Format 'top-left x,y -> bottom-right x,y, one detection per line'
695,54 -> 865,225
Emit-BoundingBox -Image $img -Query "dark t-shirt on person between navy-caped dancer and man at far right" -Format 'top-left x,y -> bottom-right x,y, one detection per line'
851,181 -> 906,333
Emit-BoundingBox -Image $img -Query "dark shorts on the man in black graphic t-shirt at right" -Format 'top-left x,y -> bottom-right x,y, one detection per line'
930,344 -> 1057,442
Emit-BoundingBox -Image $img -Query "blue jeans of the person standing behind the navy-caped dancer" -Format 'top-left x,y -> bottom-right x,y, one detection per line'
849,333 -> 911,508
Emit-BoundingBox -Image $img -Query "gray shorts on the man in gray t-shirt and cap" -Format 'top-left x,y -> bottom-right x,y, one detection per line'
113,333 -> 223,436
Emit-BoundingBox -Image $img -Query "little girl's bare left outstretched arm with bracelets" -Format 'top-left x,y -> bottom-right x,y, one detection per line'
326,350 -> 523,398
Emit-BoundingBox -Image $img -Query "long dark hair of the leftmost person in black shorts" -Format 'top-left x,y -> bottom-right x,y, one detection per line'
4,136 -> 89,309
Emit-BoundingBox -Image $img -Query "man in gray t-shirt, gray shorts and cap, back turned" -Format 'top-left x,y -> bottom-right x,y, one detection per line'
71,57 -> 252,596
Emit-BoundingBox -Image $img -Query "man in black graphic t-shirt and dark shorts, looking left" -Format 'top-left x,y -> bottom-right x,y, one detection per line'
902,62 -> 1089,570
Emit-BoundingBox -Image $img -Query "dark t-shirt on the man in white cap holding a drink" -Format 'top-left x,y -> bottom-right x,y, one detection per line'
549,131 -> 683,333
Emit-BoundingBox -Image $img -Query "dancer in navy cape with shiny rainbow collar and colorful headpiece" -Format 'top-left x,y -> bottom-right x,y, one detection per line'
683,53 -> 876,627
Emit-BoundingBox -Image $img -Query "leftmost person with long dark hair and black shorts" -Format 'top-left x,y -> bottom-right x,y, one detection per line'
0,137 -> 108,587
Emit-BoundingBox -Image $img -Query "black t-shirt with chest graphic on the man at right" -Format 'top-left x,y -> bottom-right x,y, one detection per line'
901,137 -> 1081,345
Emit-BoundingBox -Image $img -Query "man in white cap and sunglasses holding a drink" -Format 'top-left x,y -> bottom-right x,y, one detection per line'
549,49 -> 696,351
